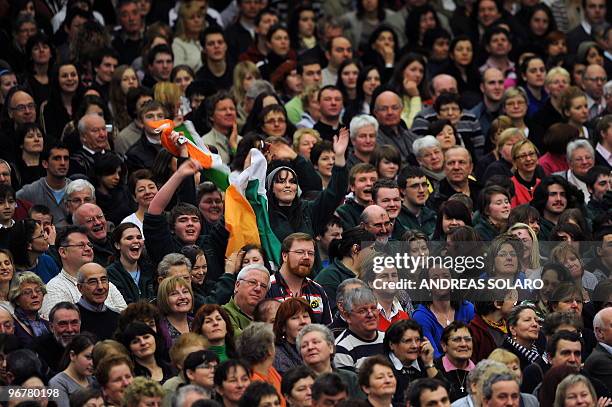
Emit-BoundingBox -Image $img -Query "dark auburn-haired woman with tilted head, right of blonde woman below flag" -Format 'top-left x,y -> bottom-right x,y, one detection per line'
192,304 -> 237,362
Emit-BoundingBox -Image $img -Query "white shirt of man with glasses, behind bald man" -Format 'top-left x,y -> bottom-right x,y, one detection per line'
40,269 -> 127,318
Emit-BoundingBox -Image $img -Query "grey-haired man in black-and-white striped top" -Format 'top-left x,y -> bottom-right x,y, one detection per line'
334,286 -> 385,372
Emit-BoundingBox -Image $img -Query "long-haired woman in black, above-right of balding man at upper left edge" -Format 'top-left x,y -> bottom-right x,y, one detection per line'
40,62 -> 80,140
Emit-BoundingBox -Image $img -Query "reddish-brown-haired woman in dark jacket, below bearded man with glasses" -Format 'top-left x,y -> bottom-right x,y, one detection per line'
273,298 -> 313,376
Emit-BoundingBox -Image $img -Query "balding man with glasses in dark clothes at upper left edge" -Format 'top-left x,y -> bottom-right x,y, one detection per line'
0,85 -> 36,162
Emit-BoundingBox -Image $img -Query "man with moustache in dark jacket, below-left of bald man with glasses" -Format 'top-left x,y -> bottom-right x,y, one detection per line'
32,301 -> 81,376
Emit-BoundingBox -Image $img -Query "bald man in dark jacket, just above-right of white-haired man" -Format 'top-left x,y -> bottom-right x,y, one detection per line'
372,90 -> 417,162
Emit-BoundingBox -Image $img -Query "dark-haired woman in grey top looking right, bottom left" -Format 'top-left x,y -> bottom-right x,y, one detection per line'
49,333 -> 95,407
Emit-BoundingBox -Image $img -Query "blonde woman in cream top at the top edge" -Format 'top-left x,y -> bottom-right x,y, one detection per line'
172,1 -> 204,72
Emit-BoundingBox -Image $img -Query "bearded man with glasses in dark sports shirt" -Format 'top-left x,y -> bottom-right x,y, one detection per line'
267,233 -> 333,325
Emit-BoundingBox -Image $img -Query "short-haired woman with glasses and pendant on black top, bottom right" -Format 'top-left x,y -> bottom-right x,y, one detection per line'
434,321 -> 475,401
